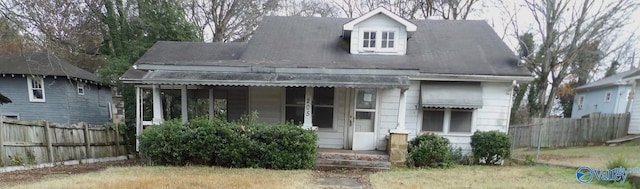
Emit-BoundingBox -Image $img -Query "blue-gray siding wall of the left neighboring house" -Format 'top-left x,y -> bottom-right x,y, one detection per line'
0,75 -> 111,124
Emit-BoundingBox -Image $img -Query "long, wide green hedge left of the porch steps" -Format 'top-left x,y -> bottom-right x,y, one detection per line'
140,115 -> 317,169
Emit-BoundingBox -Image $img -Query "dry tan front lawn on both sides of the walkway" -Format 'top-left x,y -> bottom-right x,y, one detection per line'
12,166 -> 631,189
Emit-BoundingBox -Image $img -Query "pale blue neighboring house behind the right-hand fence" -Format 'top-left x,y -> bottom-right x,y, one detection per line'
571,69 -> 638,118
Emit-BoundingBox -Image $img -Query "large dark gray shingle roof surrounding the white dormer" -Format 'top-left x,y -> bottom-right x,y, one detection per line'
123,17 -> 531,78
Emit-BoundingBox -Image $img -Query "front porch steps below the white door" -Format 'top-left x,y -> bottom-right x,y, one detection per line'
316,150 -> 391,170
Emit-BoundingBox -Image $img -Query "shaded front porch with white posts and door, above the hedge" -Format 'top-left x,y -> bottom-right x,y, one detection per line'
136,85 -> 406,152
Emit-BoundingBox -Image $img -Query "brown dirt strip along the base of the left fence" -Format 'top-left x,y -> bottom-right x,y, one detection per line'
0,160 -> 138,187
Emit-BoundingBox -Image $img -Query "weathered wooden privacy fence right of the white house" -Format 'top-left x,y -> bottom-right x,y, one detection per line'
509,114 -> 629,148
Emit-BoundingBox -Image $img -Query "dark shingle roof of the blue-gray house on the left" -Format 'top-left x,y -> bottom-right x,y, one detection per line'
0,53 -> 98,82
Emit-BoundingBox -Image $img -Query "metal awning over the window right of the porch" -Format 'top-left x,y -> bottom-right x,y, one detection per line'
420,82 -> 483,109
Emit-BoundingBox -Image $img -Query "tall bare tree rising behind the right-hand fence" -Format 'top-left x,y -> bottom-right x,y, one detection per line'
514,0 -> 640,117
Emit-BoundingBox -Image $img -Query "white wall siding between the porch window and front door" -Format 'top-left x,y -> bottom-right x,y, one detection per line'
316,88 -> 347,149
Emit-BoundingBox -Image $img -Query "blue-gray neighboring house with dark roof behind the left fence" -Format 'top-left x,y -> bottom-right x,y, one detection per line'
0,53 -> 111,124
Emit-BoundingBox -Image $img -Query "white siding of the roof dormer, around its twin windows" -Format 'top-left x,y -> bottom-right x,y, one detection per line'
350,14 -> 407,55
